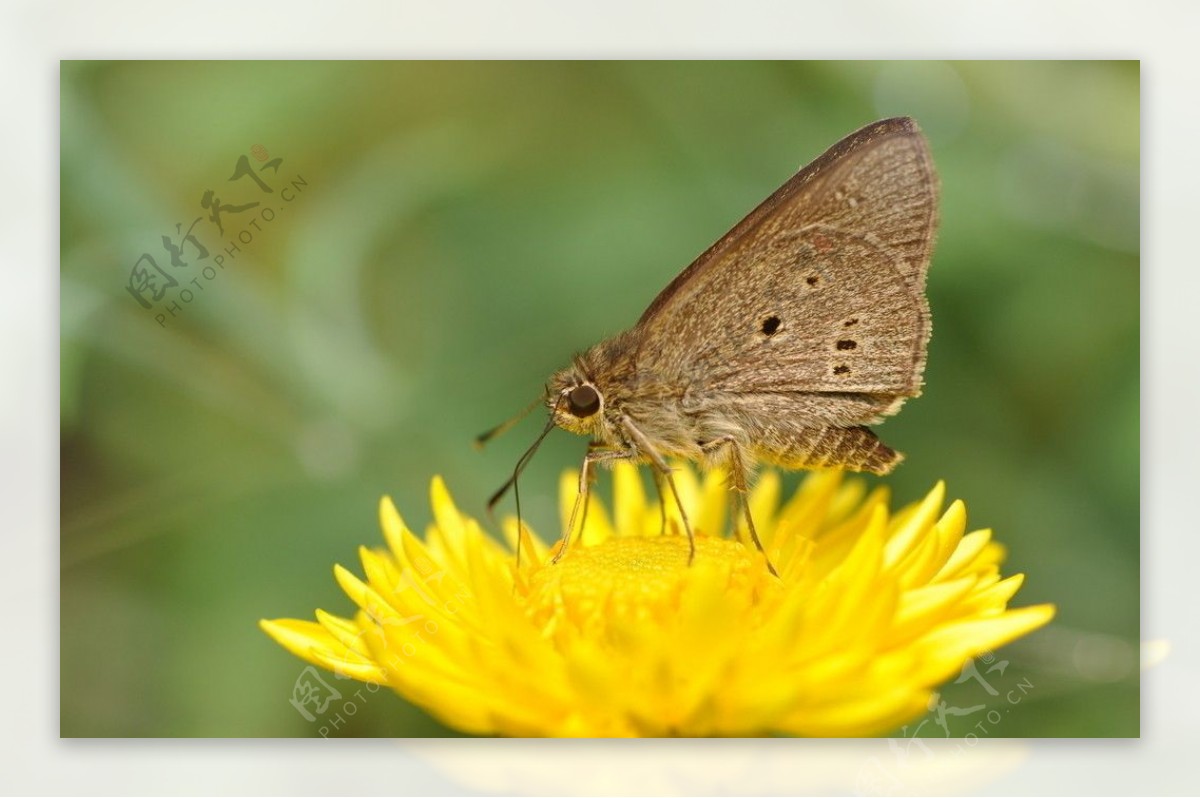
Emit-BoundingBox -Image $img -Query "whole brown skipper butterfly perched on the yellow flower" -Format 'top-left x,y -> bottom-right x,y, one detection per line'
480,118 -> 937,572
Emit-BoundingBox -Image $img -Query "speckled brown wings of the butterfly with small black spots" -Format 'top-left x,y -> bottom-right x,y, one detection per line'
638,119 -> 937,408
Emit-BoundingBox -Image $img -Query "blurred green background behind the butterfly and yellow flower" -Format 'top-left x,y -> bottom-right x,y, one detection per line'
61,62 -> 1140,737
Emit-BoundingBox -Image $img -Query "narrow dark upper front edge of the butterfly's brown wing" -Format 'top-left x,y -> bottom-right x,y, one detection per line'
637,116 -> 937,325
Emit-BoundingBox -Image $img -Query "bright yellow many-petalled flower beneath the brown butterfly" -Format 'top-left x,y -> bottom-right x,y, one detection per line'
262,464 -> 1054,737
